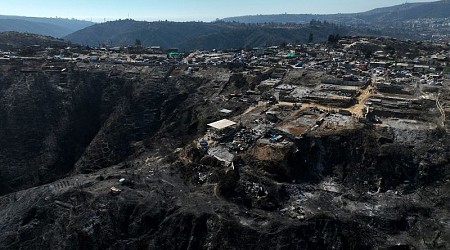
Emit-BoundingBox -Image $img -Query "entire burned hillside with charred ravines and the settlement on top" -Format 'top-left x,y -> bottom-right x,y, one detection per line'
0,37 -> 450,249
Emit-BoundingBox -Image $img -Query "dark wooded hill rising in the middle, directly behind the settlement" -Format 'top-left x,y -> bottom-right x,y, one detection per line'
65,20 -> 348,50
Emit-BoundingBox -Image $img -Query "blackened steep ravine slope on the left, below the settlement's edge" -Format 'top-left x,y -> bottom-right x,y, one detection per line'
0,63 -> 204,194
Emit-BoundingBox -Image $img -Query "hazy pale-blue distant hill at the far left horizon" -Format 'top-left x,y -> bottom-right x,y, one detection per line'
0,16 -> 94,37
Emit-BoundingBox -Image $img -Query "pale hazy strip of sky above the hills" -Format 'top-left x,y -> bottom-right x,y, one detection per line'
0,0 -> 436,21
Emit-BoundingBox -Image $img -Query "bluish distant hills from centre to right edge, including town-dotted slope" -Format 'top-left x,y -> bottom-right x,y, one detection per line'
60,1 -> 450,50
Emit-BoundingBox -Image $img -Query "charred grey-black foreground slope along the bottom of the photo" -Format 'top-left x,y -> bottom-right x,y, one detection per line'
0,115 -> 450,249
